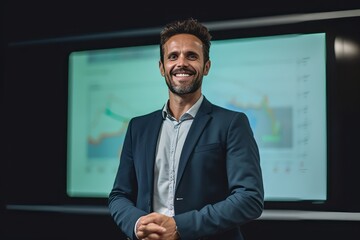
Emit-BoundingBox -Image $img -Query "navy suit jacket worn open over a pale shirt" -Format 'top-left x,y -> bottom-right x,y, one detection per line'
109,97 -> 264,240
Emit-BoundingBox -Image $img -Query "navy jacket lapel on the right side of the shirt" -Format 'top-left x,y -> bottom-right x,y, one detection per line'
175,97 -> 211,189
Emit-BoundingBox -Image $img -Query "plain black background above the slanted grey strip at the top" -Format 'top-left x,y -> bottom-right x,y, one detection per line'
2,0 -> 360,42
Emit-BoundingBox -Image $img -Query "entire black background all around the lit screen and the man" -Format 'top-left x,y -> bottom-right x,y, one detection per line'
0,0 -> 360,240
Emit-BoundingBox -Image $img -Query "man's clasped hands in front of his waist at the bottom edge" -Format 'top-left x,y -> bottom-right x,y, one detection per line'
136,213 -> 179,240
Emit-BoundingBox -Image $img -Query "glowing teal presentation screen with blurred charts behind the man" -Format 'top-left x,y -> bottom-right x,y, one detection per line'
67,33 -> 328,201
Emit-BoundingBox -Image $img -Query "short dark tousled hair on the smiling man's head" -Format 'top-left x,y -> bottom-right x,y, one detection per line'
160,18 -> 211,62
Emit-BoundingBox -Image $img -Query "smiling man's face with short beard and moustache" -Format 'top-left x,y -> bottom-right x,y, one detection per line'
159,34 -> 210,95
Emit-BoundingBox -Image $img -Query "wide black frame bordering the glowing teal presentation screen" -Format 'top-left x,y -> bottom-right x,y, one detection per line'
4,14 -> 360,211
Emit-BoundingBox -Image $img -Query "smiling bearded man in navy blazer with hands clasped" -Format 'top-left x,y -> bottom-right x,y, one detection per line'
109,19 -> 264,240
